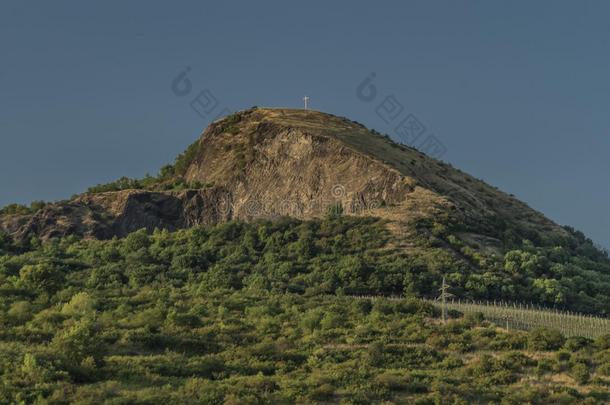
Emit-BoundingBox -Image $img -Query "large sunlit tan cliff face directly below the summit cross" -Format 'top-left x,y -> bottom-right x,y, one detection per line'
187,113 -> 414,219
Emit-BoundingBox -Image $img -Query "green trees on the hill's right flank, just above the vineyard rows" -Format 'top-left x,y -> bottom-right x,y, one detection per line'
428,218 -> 610,315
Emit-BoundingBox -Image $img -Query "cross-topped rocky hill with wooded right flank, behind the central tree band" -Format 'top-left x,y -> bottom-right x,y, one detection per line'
0,108 -> 610,314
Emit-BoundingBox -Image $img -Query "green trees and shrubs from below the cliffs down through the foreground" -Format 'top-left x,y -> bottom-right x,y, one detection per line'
0,216 -> 610,404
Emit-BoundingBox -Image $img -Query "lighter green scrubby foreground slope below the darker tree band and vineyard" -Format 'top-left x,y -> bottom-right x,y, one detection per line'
0,287 -> 610,404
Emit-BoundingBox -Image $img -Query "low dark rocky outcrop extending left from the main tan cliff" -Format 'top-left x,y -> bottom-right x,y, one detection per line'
0,189 -> 231,239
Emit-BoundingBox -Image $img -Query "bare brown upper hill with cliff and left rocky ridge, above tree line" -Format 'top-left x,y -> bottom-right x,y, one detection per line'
0,105 -> 563,238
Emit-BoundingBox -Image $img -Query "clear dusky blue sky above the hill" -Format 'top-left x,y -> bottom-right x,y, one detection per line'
0,0 -> 610,247
